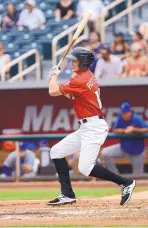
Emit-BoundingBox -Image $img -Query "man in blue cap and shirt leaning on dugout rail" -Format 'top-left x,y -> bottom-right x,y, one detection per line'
102,102 -> 148,175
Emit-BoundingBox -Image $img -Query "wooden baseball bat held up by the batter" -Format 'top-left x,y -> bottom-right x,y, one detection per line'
58,13 -> 91,67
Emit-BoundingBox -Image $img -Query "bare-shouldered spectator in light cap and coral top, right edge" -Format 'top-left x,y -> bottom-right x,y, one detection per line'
123,43 -> 148,77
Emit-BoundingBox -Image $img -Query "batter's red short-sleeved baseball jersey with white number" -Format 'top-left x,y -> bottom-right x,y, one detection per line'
60,70 -> 103,119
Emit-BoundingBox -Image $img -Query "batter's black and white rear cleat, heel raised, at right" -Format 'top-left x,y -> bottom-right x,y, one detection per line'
120,180 -> 136,206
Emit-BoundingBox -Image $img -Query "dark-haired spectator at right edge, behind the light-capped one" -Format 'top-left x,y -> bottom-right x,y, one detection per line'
132,32 -> 148,54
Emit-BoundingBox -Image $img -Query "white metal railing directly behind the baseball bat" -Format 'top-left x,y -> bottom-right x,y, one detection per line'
52,22 -> 88,66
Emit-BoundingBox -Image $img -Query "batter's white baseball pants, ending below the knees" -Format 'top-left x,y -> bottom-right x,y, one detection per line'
50,116 -> 108,176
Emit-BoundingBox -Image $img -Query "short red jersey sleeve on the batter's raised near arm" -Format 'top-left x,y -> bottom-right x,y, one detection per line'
60,78 -> 81,95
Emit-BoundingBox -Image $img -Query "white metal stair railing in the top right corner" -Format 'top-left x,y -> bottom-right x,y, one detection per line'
100,0 -> 148,42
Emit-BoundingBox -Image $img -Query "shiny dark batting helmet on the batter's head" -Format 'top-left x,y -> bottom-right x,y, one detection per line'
67,47 -> 94,69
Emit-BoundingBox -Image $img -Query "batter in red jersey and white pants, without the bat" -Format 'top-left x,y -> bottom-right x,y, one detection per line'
47,47 -> 135,205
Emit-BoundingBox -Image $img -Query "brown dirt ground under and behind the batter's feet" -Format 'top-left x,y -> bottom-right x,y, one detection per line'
0,181 -> 148,227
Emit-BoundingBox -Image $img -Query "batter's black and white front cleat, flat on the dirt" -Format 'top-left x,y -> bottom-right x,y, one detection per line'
47,194 -> 76,206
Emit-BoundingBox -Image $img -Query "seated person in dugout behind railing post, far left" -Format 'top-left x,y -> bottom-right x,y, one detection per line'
1,142 -> 40,178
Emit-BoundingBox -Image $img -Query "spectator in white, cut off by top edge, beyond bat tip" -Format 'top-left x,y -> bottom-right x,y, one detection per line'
77,0 -> 108,32
